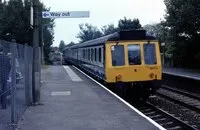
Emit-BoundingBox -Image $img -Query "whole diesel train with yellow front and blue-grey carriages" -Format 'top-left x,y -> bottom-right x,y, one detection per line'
63,30 -> 162,101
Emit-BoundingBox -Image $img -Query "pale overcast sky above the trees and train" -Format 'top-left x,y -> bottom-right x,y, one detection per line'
41,0 -> 166,46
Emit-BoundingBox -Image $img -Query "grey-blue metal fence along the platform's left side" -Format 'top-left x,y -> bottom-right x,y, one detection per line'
0,40 -> 33,130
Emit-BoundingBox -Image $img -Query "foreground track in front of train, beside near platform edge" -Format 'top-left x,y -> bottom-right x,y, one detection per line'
137,102 -> 196,130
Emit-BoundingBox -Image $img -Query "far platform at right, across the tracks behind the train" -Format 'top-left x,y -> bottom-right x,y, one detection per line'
162,68 -> 200,80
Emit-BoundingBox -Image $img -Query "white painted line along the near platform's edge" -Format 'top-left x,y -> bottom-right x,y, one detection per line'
73,66 -> 166,130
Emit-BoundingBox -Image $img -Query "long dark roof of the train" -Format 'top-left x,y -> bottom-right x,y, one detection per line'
65,30 -> 156,49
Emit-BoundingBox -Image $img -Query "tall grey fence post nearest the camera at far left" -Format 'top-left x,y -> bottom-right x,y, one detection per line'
11,39 -> 16,125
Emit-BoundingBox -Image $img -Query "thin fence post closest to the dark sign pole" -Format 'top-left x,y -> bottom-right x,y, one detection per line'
24,43 -> 31,105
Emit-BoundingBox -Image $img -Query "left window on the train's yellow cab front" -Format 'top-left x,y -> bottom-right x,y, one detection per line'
111,45 -> 125,66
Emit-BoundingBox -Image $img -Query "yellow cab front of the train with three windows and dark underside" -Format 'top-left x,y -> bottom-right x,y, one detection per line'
105,40 -> 162,101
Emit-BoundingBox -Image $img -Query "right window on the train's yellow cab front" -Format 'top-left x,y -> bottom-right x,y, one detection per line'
144,44 -> 156,65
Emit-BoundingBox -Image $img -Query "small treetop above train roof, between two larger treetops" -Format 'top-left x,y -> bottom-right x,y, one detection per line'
101,24 -> 118,35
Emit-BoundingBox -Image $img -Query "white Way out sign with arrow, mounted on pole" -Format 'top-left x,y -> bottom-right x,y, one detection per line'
42,11 -> 90,18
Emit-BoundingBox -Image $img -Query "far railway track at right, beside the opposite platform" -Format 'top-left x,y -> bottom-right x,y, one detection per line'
156,86 -> 200,113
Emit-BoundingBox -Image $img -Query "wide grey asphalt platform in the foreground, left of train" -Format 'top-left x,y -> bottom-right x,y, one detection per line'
18,66 -> 164,130
